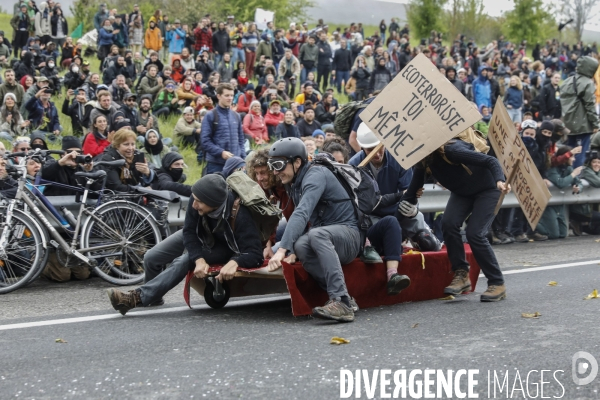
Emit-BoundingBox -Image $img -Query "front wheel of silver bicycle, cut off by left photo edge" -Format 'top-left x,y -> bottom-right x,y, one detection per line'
0,209 -> 48,294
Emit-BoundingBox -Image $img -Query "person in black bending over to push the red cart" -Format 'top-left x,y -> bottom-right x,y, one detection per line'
399,139 -> 510,301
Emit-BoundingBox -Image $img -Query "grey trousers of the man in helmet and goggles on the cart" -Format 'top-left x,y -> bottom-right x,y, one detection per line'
294,225 -> 361,299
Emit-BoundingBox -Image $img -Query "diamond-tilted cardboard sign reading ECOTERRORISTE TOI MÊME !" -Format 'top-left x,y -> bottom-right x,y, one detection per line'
360,54 -> 481,169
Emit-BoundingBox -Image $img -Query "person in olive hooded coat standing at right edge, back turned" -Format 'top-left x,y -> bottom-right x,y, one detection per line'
560,56 -> 600,168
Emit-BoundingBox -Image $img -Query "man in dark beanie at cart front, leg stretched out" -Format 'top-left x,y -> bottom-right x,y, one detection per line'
108,174 -> 264,315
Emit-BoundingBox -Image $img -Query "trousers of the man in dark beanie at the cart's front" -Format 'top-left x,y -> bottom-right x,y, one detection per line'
140,230 -> 190,306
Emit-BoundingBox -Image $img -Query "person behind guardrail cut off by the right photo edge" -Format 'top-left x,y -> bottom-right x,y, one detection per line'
570,151 -> 600,236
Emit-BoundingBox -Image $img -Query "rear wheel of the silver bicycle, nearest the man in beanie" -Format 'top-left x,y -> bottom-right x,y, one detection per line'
81,200 -> 162,285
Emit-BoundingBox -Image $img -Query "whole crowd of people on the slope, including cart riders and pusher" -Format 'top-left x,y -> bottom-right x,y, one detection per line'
0,5 -> 600,321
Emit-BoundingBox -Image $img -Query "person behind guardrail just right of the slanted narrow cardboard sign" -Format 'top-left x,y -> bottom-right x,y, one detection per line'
535,146 -> 583,239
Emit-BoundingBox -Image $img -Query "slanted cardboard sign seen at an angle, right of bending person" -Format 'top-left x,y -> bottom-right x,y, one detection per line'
488,99 -> 552,229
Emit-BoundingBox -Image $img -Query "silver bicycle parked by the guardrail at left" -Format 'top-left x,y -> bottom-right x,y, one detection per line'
0,150 -> 169,294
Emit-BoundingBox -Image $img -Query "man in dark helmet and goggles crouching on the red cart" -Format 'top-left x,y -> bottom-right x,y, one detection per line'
268,138 -> 361,322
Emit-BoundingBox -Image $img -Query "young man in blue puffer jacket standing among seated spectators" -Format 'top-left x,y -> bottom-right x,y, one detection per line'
200,83 -> 246,174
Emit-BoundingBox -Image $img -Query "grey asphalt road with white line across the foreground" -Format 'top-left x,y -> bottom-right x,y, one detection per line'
0,237 -> 600,399
